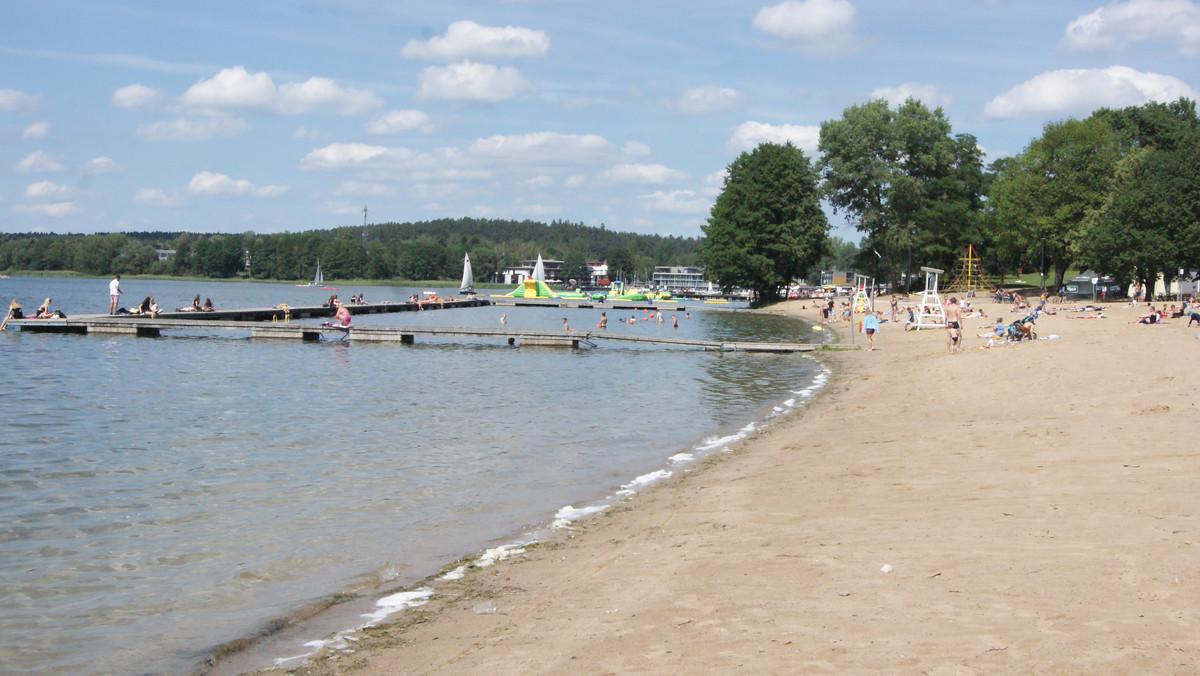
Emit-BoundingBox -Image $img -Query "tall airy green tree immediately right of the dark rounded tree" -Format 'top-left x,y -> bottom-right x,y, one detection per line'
818,98 -> 984,289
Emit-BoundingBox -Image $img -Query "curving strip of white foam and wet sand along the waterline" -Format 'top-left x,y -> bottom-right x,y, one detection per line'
199,309 -> 836,676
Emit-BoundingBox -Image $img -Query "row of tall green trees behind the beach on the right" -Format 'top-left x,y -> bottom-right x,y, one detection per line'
816,98 -> 1200,292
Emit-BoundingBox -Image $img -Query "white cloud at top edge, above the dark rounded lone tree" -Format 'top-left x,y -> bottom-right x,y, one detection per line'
754,0 -> 854,54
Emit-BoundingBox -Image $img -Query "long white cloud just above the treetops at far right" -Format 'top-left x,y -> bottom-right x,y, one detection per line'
984,66 -> 1196,118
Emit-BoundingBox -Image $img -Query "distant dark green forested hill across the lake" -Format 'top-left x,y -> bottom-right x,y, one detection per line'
0,219 -> 700,281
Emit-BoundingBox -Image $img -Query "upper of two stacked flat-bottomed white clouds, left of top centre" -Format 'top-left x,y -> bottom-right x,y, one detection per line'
400,20 -> 550,61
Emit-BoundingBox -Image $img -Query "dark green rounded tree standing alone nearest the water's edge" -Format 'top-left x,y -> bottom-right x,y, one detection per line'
700,143 -> 829,305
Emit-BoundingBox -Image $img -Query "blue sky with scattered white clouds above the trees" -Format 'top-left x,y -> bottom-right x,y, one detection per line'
0,0 -> 1200,241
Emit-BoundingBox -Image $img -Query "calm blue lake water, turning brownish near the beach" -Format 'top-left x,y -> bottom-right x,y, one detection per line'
0,279 -> 823,675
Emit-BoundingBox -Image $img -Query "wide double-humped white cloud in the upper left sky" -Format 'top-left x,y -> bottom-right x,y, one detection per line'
180,66 -> 383,115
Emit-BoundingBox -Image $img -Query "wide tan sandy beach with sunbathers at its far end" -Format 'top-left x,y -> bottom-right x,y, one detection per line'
274,301 -> 1200,675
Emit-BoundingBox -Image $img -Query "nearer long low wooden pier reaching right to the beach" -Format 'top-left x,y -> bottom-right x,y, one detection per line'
8,316 -> 822,353
